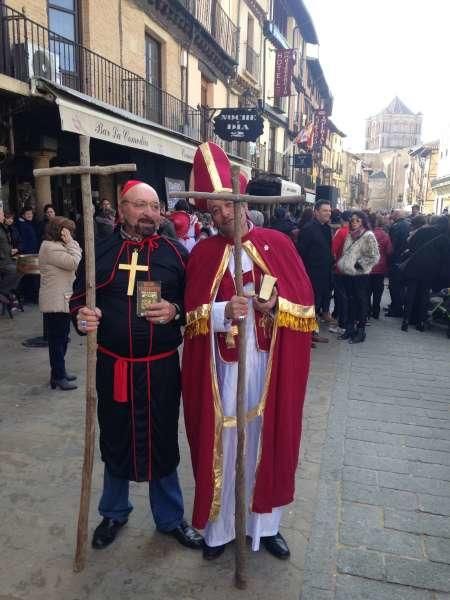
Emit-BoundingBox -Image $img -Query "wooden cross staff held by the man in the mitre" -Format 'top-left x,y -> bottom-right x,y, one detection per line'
169,170 -> 302,589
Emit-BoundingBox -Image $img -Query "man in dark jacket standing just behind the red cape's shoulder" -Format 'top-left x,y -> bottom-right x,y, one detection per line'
297,200 -> 333,341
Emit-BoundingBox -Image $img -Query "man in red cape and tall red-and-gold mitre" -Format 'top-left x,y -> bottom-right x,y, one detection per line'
182,143 -> 316,560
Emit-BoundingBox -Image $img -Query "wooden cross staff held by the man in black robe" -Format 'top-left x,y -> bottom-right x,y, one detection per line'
33,135 -> 137,572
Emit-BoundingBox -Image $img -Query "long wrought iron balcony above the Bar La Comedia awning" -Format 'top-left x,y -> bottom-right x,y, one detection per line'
0,5 -> 202,140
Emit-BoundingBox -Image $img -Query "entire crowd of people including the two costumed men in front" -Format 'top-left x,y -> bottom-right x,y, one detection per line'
0,142 -> 450,560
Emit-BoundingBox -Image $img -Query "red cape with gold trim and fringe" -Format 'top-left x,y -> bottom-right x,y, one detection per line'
182,228 -> 316,528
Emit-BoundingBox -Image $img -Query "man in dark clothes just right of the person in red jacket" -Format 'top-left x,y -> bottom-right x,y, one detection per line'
387,210 -> 411,317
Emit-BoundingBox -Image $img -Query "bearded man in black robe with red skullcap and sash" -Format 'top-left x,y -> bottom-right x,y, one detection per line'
70,180 -> 202,549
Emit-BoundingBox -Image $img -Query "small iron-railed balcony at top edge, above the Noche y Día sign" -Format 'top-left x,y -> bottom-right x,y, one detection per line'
180,0 -> 239,61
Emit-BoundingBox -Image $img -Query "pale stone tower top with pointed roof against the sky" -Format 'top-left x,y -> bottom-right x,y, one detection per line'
366,96 -> 422,152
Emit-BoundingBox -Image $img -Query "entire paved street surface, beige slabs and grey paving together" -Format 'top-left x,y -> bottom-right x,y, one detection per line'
0,307 -> 450,600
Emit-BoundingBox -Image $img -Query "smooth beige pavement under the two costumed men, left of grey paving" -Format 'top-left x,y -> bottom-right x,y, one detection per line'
0,307 -> 339,600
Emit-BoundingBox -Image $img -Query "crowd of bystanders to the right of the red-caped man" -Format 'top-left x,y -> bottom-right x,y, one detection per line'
260,200 -> 450,343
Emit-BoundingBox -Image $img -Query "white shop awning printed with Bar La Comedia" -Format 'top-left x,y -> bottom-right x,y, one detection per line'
56,96 -> 197,163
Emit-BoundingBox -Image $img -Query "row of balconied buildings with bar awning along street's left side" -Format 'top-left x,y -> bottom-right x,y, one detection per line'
0,0 -> 340,214
